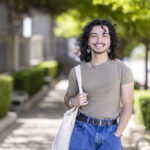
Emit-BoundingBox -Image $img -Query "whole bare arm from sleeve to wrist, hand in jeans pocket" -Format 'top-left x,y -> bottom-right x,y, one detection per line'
116,82 -> 134,135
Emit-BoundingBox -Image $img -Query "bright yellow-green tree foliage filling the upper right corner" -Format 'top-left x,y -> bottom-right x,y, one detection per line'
93,0 -> 150,42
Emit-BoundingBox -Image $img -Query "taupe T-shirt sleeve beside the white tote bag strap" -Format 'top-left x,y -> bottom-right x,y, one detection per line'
67,68 -> 79,96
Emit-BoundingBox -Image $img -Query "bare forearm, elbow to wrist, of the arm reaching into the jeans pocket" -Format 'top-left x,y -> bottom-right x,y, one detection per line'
116,106 -> 132,134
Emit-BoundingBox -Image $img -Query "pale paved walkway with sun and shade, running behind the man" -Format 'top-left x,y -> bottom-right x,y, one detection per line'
0,80 -> 132,150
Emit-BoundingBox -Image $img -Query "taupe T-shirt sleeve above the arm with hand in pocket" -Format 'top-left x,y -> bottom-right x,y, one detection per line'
121,64 -> 134,84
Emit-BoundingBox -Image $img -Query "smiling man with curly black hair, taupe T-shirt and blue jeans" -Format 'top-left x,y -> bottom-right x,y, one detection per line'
64,20 -> 134,150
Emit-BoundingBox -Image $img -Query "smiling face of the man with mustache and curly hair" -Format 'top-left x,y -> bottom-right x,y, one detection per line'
88,25 -> 110,54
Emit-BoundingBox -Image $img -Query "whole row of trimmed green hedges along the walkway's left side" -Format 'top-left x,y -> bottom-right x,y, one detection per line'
0,61 -> 58,118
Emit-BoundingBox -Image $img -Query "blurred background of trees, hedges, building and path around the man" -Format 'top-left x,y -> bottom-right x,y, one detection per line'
0,0 -> 150,150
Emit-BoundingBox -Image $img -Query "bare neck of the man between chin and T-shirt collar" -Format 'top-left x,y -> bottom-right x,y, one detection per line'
91,53 -> 109,65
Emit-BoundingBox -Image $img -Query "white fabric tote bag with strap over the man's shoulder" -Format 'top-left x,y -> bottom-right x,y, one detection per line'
52,65 -> 83,150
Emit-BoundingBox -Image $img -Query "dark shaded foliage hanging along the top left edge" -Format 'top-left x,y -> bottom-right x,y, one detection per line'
0,0 -> 73,15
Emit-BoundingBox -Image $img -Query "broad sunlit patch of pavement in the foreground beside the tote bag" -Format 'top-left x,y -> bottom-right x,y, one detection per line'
0,118 -> 61,150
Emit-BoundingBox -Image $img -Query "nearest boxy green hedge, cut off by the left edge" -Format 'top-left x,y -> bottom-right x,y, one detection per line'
0,76 -> 13,118
